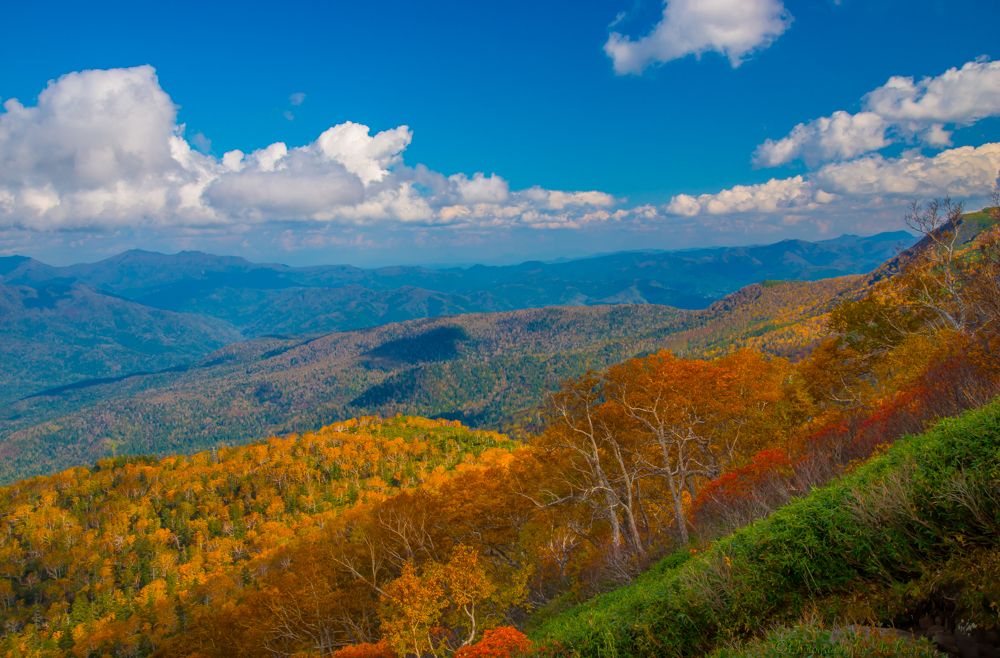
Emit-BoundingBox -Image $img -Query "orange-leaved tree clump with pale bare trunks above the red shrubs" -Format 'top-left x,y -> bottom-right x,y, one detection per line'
533,350 -> 808,556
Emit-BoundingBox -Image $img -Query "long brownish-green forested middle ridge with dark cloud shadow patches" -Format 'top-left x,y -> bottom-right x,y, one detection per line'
0,270 -> 858,481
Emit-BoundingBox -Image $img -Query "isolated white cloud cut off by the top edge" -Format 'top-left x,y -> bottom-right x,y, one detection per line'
604,0 -> 792,75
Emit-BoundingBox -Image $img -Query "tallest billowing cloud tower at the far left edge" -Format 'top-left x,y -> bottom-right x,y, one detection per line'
0,66 -> 187,228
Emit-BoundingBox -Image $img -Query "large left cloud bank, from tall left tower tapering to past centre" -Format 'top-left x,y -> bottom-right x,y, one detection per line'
0,66 -> 617,230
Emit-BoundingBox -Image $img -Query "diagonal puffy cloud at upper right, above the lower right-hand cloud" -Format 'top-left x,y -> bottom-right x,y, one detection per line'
753,59 -> 1000,167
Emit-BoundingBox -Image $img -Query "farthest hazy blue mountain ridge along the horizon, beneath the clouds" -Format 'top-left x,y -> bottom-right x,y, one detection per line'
0,231 -> 915,311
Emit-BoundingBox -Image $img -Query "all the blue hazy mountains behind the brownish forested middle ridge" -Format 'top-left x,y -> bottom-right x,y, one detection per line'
0,232 -> 914,404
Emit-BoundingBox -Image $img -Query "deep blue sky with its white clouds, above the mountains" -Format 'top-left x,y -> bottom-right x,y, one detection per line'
0,0 -> 1000,265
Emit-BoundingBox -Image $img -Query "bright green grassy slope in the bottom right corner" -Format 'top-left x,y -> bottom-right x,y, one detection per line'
534,394 -> 1000,656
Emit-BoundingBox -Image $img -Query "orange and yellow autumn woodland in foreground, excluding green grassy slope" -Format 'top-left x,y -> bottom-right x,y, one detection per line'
0,201 -> 1000,658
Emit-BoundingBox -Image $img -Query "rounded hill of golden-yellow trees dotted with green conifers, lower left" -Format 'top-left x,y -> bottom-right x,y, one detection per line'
0,417 -> 516,655
